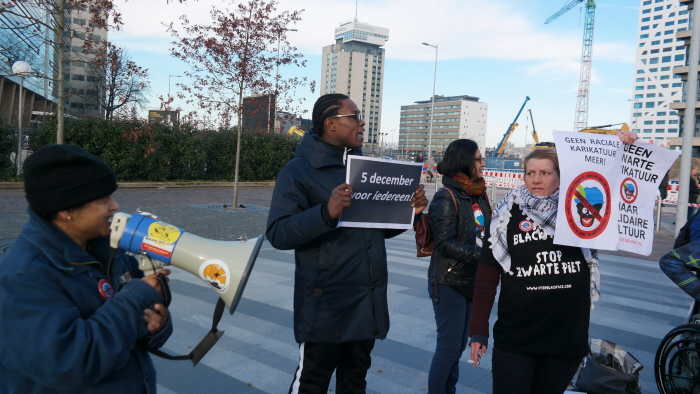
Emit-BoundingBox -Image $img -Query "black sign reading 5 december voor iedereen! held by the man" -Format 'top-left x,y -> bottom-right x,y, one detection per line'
338,156 -> 422,230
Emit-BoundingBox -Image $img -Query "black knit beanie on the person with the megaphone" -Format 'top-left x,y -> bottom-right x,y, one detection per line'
23,145 -> 117,213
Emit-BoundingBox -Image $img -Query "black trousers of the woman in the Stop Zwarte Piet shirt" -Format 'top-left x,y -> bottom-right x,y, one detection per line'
491,349 -> 583,394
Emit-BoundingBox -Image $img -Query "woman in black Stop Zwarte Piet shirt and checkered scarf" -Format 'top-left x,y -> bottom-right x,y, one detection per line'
470,138 -> 636,394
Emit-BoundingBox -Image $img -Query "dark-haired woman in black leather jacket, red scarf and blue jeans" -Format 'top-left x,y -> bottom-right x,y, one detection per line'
428,139 -> 491,394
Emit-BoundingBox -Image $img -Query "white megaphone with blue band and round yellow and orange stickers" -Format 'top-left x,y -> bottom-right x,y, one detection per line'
110,210 -> 264,314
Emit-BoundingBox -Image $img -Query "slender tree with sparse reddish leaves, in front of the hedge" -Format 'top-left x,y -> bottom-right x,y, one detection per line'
168,0 -> 313,207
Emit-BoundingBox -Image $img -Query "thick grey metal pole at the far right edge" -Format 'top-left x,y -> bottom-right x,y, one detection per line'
674,4 -> 700,235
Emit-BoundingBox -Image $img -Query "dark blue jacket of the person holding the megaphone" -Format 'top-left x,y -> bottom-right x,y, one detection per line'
0,210 -> 172,394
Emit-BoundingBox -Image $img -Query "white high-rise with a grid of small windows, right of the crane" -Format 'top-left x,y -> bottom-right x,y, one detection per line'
630,0 -> 689,147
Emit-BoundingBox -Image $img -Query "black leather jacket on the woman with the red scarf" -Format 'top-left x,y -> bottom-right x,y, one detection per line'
428,177 -> 491,302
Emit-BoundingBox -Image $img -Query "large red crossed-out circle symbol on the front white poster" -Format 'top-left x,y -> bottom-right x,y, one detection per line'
564,171 -> 612,239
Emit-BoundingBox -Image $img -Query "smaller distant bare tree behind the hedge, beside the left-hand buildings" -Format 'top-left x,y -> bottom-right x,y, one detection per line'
85,42 -> 150,120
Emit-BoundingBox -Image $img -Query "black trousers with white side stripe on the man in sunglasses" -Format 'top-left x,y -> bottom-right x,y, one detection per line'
289,339 -> 374,394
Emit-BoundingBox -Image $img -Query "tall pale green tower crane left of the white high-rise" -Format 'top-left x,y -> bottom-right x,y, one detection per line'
544,0 -> 595,131
